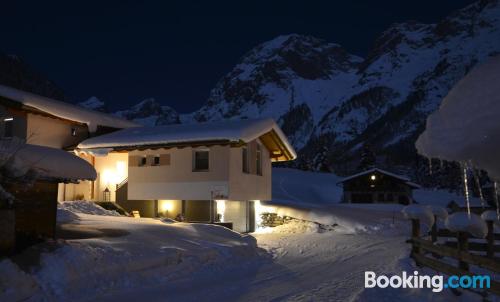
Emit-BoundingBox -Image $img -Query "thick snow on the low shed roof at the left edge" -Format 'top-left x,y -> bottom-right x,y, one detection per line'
0,139 -> 97,182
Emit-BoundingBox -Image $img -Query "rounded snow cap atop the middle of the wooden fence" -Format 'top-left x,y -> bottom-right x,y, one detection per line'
445,212 -> 488,238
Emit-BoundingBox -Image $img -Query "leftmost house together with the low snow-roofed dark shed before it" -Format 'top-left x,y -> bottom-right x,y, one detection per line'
0,85 -> 137,247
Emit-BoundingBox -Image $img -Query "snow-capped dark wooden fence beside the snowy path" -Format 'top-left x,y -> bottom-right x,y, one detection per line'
403,205 -> 500,295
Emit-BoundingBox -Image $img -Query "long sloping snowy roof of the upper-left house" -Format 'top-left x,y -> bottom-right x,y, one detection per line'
0,85 -> 139,132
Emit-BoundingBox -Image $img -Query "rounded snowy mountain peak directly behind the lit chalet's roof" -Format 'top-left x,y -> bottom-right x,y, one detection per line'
193,34 -> 362,148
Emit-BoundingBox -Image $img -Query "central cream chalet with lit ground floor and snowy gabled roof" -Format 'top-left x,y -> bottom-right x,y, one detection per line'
77,119 -> 296,232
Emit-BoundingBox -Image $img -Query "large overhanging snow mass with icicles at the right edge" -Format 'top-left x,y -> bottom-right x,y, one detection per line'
415,55 -> 500,180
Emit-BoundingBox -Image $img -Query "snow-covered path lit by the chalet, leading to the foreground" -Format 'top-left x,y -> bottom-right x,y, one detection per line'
94,212 -> 481,302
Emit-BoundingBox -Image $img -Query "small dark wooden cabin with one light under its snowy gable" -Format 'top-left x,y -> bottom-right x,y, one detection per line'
339,168 -> 420,204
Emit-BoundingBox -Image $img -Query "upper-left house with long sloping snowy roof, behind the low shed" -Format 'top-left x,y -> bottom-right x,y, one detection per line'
0,85 -> 138,200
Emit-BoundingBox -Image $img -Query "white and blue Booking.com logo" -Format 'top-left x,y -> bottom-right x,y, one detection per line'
365,271 -> 491,293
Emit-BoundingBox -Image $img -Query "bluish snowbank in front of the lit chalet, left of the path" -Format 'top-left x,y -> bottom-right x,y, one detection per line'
0,208 -> 258,301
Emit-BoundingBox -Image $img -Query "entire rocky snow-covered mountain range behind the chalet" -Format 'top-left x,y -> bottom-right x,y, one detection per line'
186,0 -> 500,174
